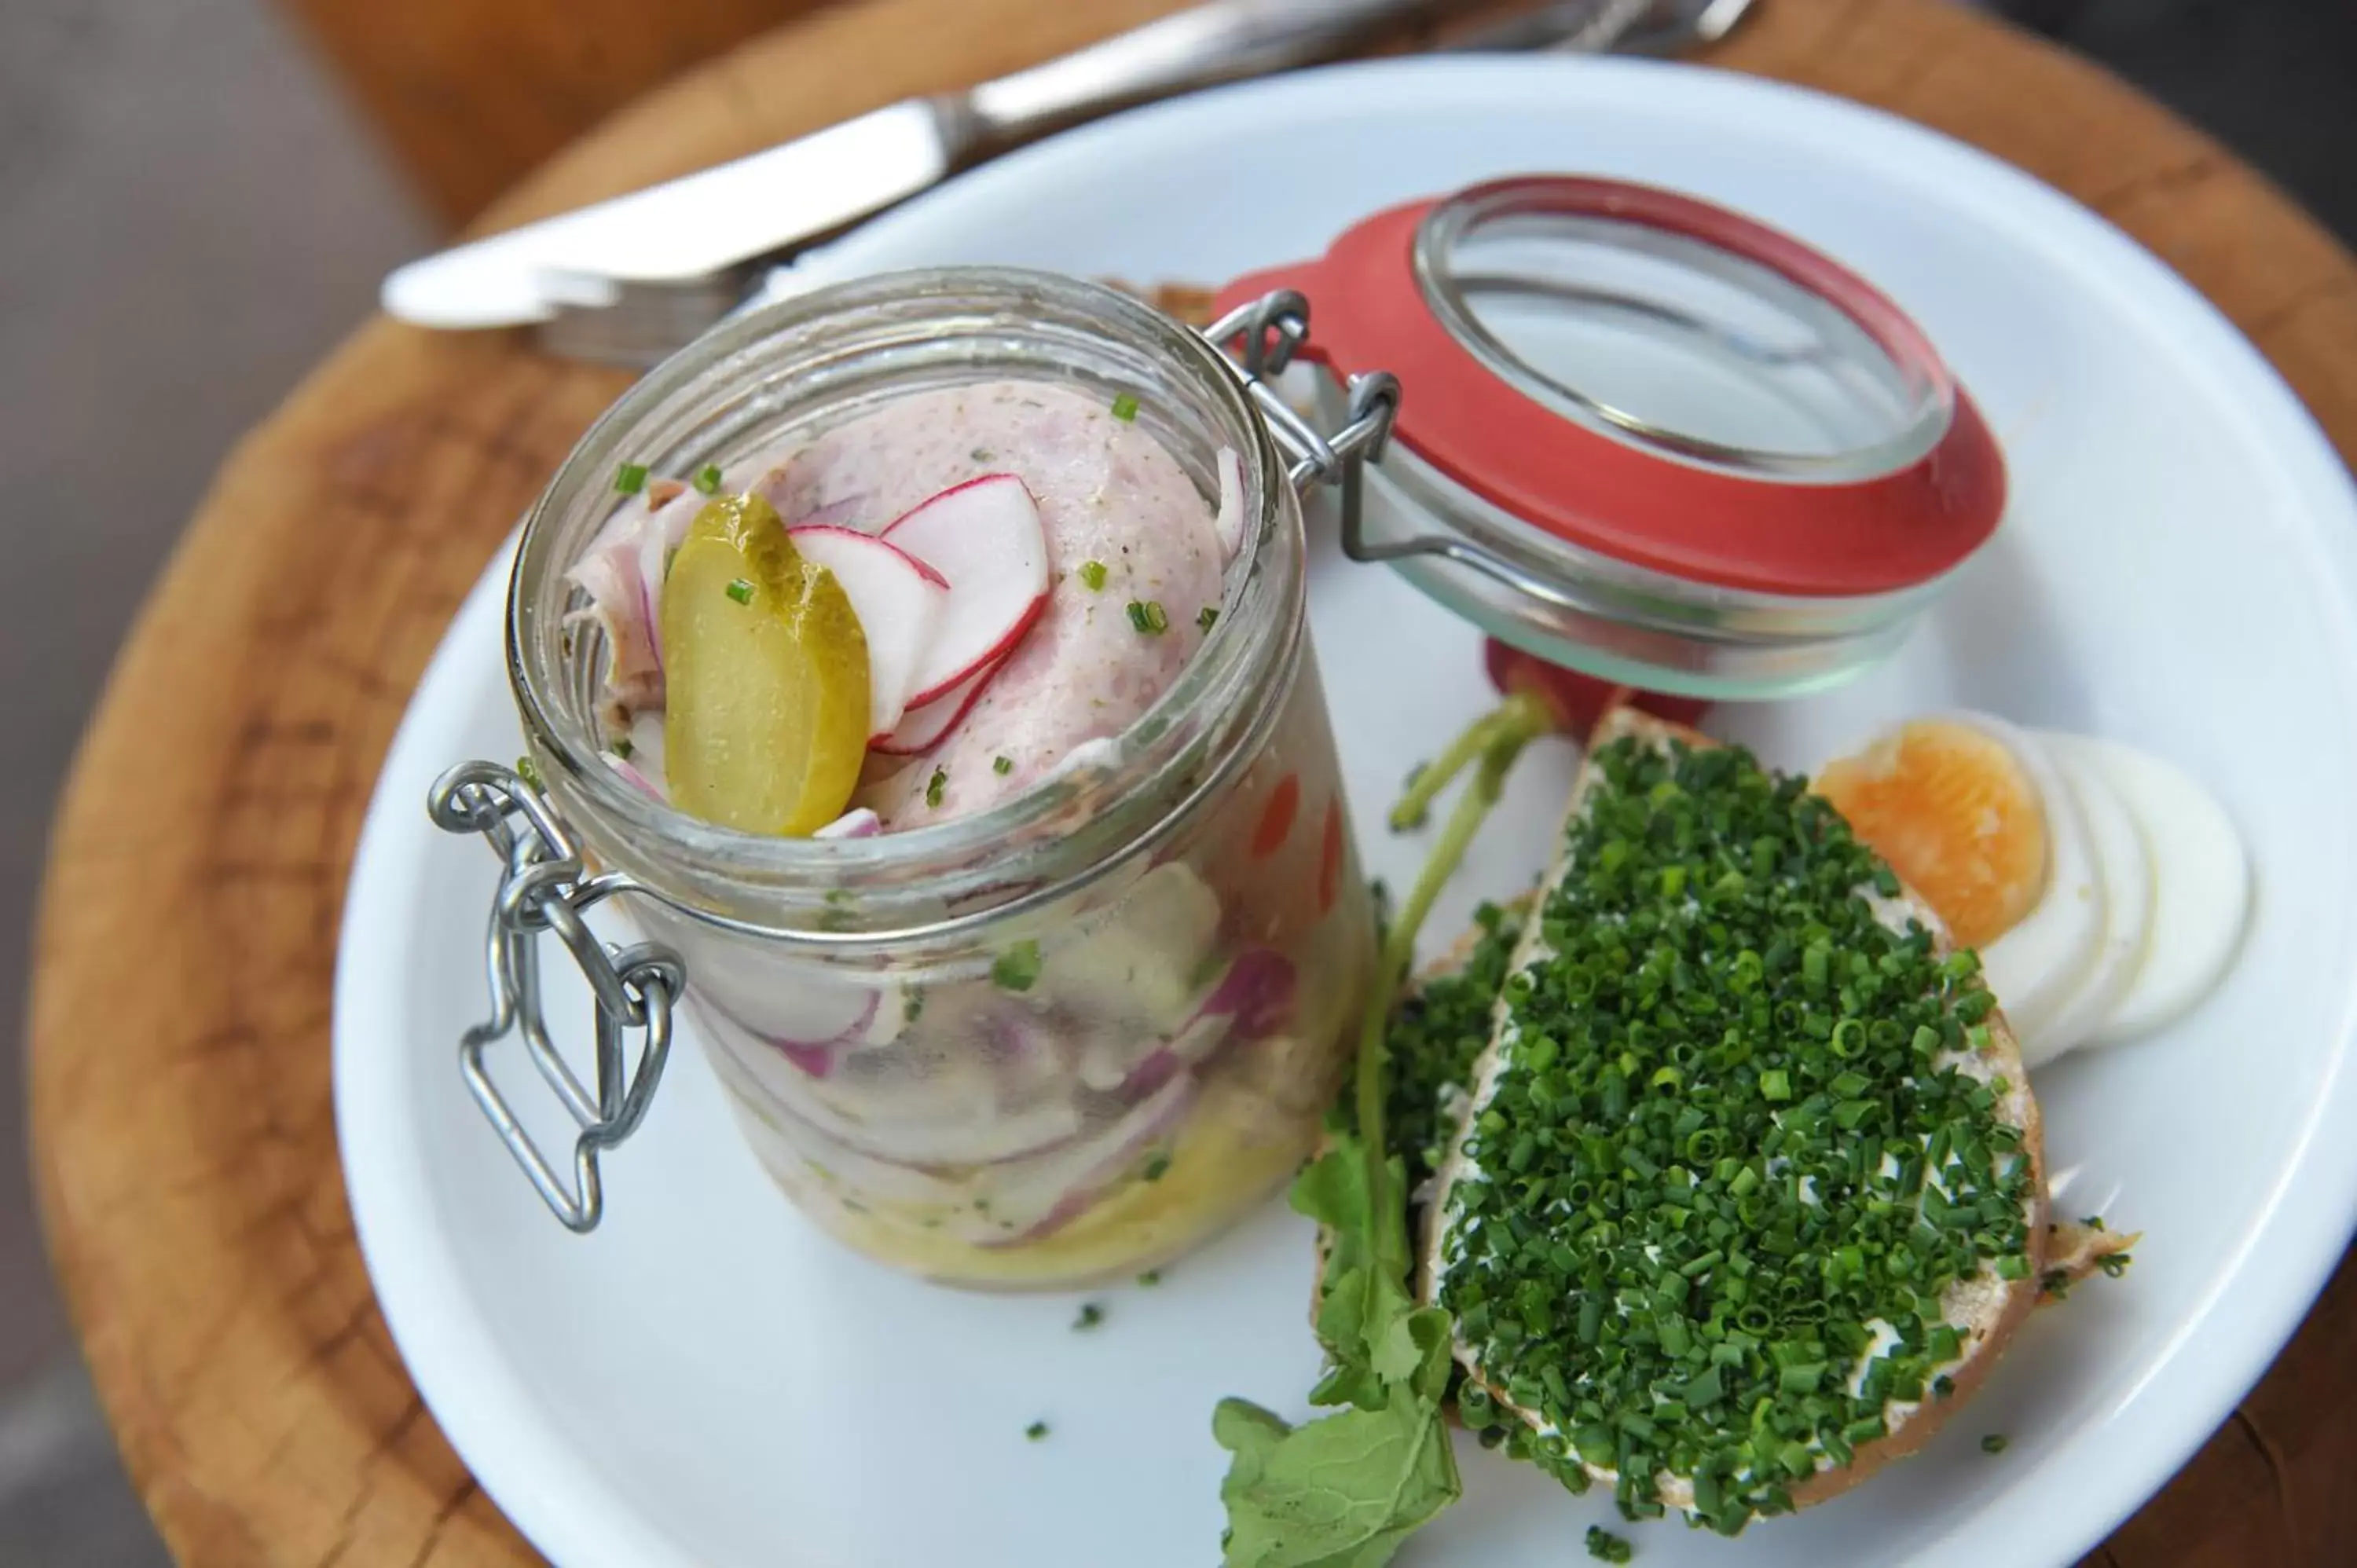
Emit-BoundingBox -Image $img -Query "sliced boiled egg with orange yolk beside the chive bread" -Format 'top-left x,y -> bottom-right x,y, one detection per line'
1817,712 -> 2251,1068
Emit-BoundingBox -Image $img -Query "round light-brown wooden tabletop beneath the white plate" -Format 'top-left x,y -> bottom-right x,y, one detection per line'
31,0 -> 2357,1568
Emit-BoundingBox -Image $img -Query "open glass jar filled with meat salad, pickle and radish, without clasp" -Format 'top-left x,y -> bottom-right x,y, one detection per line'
457,269 -> 1372,1285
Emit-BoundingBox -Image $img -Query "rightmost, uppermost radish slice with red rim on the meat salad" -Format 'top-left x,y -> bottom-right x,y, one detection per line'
884,474 -> 1047,709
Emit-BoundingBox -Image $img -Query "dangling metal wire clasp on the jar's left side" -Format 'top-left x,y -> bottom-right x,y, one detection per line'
427,761 -> 686,1233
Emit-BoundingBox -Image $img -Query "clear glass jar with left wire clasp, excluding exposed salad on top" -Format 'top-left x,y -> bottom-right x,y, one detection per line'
436,269 -> 1374,1288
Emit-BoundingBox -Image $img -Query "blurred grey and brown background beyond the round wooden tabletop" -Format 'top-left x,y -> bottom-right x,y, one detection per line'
0,0 -> 2357,1568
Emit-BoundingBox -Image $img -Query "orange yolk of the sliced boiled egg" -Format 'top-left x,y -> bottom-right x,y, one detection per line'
1817,719 -> 2046,948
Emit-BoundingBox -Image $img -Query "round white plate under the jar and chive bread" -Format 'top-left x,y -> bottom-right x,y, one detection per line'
335,59 -> 2357,1568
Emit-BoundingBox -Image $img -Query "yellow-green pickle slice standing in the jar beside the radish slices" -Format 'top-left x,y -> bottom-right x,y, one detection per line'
662,495 -> 870,837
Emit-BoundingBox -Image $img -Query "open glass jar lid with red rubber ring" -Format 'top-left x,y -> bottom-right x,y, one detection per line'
1223,174 -> 2006,695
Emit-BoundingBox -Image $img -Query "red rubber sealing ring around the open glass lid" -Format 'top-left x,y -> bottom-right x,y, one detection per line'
1219,177 -> 2006,596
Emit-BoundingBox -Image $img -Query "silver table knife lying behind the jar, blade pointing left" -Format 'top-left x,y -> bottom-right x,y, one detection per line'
382,0 -> 1447,328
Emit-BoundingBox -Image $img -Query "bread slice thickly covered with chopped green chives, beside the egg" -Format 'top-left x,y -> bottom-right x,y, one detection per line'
1417,707 -> 2051,1530
